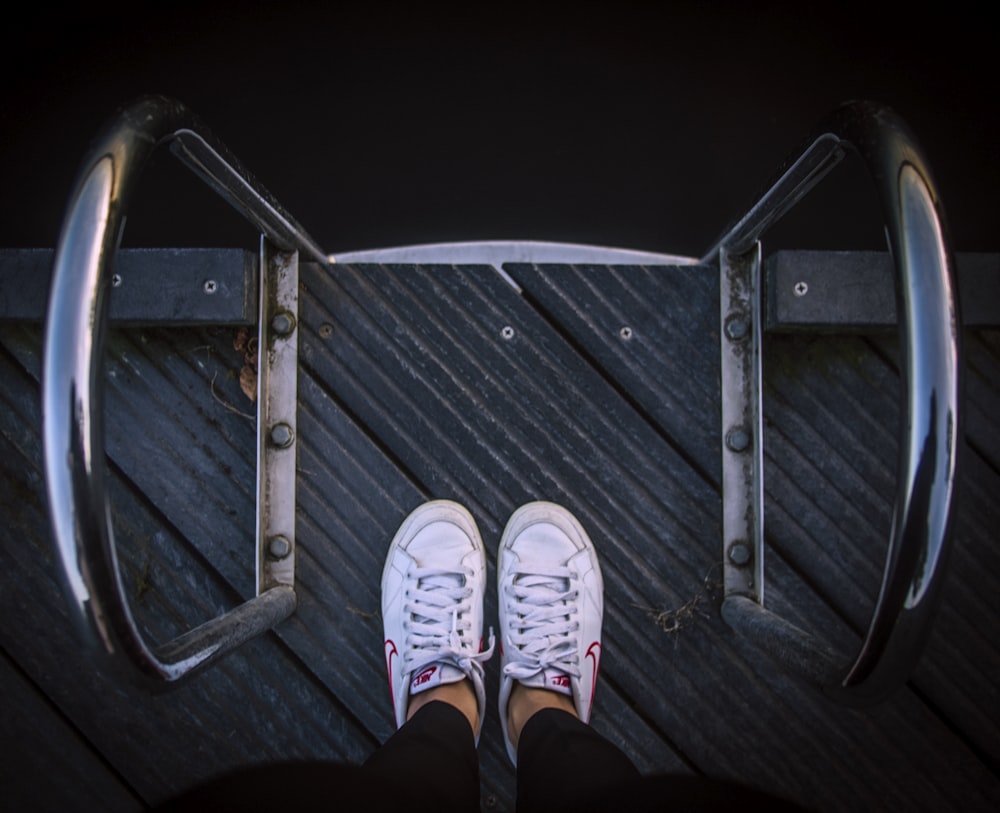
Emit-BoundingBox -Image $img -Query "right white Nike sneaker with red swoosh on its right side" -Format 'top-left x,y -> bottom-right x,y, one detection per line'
497,502 -> 604,765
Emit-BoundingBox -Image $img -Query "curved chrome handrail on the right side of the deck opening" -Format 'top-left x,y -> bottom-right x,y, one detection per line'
703,102 -> 963,705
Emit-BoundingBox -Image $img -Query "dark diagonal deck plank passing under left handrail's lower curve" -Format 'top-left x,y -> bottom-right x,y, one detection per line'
0,328 -> 373,810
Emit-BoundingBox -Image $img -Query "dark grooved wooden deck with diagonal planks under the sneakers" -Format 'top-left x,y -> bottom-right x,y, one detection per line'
0,263 -> 1000,811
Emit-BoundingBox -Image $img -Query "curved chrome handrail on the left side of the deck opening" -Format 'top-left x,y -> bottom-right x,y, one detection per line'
42,96 -> 327,681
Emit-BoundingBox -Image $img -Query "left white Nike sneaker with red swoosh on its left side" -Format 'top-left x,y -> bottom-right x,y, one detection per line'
382,500 -> 493,744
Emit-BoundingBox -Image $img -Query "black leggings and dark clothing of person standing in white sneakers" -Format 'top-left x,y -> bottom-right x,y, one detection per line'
155,702 -> 801,813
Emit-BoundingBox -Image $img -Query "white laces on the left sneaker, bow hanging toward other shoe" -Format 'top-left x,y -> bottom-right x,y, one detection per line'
403,568 -> 494,676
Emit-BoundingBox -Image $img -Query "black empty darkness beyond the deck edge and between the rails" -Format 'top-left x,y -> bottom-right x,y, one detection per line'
0,2 -> 1000,256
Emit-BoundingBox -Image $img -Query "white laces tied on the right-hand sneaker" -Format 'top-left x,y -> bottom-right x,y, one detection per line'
503,566 -> 580,680
